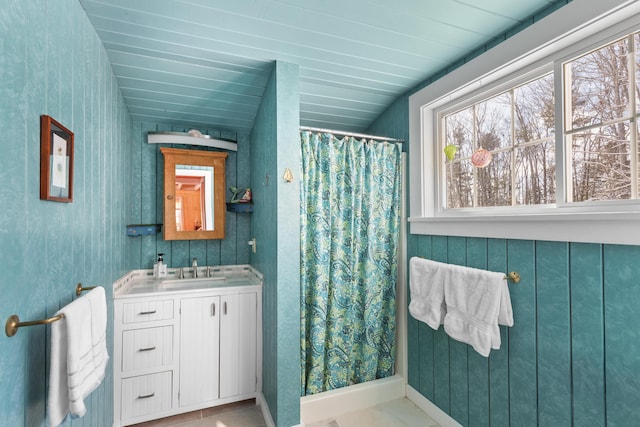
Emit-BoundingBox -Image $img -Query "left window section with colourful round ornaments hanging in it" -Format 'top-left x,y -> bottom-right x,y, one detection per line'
440,74 -> 556,209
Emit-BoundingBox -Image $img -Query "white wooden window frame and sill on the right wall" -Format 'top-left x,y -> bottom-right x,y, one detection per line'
409,0 -> 640,244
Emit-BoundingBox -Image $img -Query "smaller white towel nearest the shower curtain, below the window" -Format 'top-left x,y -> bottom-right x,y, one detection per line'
409,257 -> 449,330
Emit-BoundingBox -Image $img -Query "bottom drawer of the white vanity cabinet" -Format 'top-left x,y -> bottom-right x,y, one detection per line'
121,371 -> 172,420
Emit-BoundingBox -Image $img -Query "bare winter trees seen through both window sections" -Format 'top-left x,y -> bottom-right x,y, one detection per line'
440,33 -> 640,209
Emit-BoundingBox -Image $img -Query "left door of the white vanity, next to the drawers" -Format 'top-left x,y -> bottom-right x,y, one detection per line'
180,297 -> 220,406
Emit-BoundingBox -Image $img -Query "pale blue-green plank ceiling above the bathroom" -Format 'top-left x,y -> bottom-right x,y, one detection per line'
80,0 -> 564,133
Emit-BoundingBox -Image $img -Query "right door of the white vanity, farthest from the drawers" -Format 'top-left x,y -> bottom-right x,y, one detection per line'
220,293 -> 257,398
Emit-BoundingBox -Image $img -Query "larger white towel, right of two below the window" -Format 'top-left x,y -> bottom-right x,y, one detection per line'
444,265 -> 513,357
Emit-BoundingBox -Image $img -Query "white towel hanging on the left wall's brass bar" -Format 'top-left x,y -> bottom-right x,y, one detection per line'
48,287 -> 109,427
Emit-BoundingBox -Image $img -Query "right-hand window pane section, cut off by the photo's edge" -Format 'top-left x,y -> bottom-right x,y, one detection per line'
564,33 -> 640,202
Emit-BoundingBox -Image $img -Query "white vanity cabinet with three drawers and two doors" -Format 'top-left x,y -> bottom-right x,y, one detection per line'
113,268 -> 262,427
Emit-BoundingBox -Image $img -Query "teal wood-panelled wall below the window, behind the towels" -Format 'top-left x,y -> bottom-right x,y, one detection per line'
408,235 -> 640,427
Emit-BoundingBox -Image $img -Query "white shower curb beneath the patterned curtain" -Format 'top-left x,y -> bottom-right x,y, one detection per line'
300,375 -> 405,425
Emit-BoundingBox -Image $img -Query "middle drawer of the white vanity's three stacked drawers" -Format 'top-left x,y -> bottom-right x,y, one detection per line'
122,325 -> 173,372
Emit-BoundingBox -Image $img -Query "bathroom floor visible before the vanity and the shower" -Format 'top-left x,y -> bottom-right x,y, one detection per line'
133,399 -> 439,427
